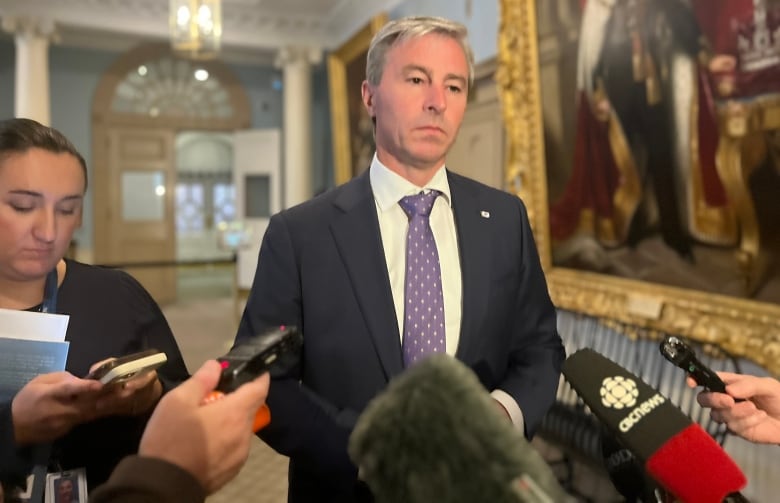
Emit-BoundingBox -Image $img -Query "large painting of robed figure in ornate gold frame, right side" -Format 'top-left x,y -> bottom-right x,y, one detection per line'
496,0 -> 780,375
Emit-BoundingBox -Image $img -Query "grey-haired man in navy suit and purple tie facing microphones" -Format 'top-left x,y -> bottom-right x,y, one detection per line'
236,13 -> 564,502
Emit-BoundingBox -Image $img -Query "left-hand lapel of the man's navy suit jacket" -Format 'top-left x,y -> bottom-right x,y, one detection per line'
331,171 -> 403,380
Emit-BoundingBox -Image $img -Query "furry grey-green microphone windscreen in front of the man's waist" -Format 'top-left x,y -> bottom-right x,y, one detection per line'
349,354 -> 571,503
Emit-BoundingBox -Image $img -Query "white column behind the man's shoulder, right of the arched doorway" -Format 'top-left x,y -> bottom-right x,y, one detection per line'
276,47 -> 322,208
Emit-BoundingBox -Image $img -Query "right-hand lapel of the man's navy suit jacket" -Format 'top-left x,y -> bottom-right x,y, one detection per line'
447,171 -> 490,363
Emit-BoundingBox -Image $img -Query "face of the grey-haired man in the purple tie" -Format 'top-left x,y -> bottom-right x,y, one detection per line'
362,33 -> 468,178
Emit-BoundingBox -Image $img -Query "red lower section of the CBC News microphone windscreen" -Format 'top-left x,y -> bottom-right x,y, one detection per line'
645,423 -> 747,503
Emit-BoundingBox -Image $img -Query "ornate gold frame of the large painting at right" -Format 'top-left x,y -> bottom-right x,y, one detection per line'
496,0 -> 780,375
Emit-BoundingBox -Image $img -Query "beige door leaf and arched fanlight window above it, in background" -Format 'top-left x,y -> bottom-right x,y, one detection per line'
92,44 -> 251,304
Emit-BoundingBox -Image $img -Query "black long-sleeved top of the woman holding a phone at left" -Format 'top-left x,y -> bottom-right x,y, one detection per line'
0,260 -> 189,488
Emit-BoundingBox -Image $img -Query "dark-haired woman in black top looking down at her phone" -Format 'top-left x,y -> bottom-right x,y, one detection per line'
0,119 -> 188,497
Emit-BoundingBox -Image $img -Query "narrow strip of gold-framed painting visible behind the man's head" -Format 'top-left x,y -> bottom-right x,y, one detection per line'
328,13 -> 388,185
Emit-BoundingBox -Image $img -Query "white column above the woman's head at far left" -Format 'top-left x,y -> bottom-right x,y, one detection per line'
3,17 -> 54,126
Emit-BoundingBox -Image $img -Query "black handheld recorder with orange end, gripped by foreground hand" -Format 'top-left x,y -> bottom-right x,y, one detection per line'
206,325 -> 303,432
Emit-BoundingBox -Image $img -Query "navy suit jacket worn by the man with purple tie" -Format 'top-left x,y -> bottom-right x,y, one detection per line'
236,172 -> 564,502
